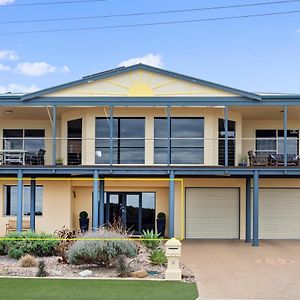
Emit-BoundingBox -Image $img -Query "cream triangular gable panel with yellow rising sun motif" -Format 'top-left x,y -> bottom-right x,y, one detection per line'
47,70 -> 237,97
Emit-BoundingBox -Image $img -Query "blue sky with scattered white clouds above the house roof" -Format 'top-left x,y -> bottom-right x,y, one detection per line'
0,0 -> 300,93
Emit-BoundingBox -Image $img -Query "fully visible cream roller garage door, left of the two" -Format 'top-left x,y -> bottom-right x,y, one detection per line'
185,188 -> 239,239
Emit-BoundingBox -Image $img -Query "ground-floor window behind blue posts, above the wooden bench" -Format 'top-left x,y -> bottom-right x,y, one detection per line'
4,185 -> 43,216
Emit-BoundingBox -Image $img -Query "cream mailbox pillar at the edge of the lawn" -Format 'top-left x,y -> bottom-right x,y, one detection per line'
165,238 -> 181,280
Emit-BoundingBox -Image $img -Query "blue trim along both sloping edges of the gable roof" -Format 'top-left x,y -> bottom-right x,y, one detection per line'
21,64 -> 261,101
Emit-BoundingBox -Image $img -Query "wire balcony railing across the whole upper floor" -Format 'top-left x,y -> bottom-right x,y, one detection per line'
0,137 -> 299,166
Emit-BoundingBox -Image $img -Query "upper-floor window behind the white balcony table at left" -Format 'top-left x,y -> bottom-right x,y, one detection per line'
3,129 -> 45,153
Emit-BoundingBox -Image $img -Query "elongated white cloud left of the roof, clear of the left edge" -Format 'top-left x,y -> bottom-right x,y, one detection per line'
16,62 -> 70,76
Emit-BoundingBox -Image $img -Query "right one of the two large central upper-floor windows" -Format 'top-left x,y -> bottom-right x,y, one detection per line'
154,118 -> 204,164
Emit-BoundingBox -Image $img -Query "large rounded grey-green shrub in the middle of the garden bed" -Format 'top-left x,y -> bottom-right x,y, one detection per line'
68,229 -> 137,266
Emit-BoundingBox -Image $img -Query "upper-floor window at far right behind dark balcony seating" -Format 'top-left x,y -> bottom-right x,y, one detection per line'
256,129 -> 299,154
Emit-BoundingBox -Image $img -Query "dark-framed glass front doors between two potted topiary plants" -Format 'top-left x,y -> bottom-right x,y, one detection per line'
105,192 -> 155,234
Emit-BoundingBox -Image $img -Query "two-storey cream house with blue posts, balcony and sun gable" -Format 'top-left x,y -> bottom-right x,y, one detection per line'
0,64 -> 300,245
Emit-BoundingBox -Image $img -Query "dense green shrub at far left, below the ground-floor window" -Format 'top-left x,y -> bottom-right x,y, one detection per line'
4,231 -> 59,259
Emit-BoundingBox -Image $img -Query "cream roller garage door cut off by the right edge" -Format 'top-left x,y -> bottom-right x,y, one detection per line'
259,189 -> 300,239
